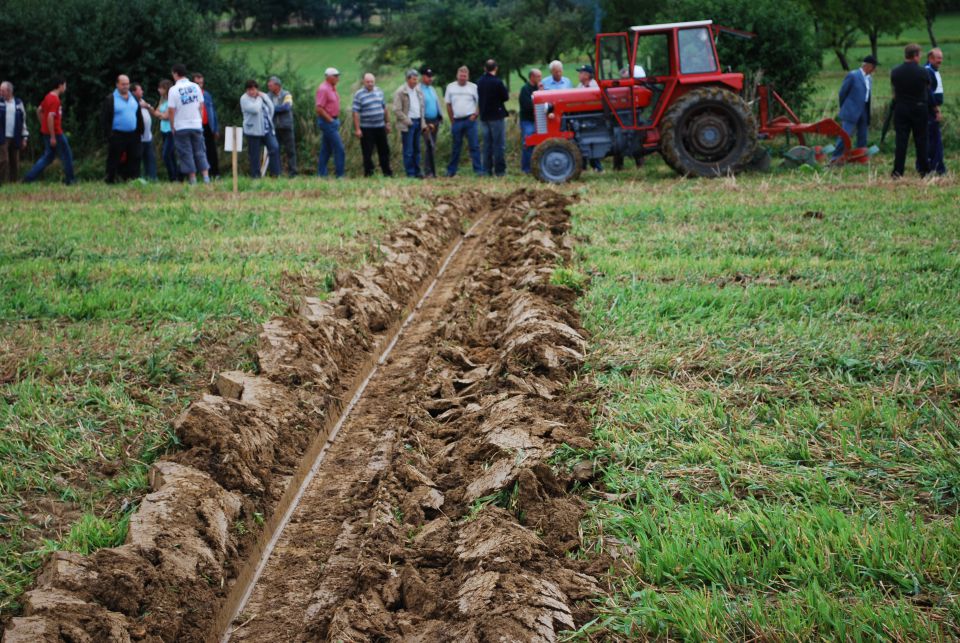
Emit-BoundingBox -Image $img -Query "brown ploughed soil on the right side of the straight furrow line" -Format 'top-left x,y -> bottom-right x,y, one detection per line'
230,195 -> 595,641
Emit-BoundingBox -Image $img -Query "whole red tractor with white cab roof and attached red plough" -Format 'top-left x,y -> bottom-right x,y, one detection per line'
526,20 -> 863,183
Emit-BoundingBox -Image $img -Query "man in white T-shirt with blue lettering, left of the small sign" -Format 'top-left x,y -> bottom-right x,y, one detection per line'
167,63 -> 210,184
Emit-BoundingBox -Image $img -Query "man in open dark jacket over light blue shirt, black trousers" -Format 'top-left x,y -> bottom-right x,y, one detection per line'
100,74 -> 143,183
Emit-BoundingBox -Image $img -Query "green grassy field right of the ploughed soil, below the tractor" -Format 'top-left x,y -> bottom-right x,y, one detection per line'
563,165 -> 960,640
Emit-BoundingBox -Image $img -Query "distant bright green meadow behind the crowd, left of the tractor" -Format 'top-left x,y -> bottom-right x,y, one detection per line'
220,36 -> 374,90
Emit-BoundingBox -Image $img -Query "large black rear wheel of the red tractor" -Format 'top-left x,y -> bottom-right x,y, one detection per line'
660,87 -> 757,177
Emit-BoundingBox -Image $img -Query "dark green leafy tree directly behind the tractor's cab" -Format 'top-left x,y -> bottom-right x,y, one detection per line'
659,0 -> 822,108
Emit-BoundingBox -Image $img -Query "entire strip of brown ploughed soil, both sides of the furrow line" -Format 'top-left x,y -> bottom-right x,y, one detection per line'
4,192 -> 599,642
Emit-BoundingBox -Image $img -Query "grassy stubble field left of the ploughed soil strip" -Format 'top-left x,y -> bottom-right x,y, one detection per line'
0,179 -> 425,622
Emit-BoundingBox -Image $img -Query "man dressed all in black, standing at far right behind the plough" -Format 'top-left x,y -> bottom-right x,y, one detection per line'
890,44 -> 930,179
